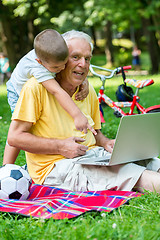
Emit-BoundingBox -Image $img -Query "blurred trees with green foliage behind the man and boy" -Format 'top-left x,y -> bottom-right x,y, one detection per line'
0,0 -> 160,73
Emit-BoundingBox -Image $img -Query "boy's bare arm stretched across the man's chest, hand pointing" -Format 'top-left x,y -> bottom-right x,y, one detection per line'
42,79 -> 96,134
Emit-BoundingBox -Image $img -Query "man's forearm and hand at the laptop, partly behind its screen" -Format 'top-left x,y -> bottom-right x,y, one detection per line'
95,130 -> 115,152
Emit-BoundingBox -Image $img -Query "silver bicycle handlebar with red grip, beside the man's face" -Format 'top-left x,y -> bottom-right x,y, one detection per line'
89,64 -> 132,81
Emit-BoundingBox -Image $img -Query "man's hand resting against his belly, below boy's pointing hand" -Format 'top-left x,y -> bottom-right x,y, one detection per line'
59,137 -> 88,158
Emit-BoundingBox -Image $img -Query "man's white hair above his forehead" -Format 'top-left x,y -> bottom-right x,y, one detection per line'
62,30 -> 93,51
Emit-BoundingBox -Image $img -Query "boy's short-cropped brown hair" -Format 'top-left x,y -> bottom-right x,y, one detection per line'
34,29 -> 68,62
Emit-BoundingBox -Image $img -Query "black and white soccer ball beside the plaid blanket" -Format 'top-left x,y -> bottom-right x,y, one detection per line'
0,164 -> 31,200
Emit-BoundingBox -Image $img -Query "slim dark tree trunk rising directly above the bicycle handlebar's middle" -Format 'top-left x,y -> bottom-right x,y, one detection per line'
104,21 -> 114,67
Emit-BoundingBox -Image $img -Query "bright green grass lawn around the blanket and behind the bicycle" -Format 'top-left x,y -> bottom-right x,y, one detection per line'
0,70 -> 160,240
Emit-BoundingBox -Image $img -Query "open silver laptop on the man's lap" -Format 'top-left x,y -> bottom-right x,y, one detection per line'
74,112 -> 160,166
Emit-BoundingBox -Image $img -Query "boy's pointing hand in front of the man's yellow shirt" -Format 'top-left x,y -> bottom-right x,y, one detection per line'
74,113 -> 97,135
